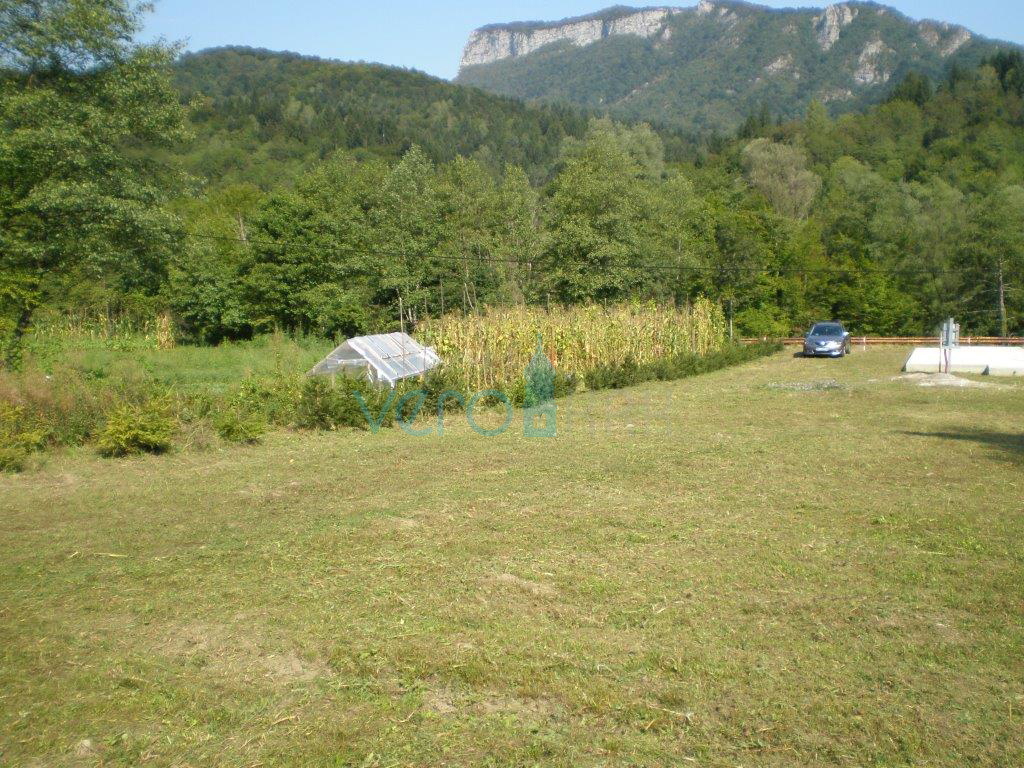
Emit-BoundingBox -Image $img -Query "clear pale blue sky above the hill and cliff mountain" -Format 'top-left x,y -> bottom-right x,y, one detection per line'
142,0 -> 1024,78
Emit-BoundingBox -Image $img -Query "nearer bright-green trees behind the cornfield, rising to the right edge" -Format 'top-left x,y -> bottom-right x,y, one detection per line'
167,54 -> 1024,338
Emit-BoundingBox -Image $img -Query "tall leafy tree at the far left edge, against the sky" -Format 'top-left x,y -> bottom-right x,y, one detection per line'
0,0 -> 184,357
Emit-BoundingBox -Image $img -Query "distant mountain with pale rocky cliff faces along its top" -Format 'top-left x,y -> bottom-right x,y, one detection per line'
457,0 -> 1010,131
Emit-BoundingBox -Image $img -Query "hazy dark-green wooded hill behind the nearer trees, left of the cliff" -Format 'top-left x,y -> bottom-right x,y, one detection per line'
173,48 -> 587,188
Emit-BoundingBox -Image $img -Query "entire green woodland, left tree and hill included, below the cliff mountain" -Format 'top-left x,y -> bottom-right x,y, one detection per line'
0,0 -> 1024,359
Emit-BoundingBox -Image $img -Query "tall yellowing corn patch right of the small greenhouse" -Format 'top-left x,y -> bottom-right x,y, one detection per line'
417,298 -> 725,390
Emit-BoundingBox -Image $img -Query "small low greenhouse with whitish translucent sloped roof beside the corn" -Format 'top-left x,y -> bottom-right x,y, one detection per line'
309,333 -> 441,387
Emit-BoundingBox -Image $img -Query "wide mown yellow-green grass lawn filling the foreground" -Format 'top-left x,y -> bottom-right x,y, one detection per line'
0,349 -> 1024,766
